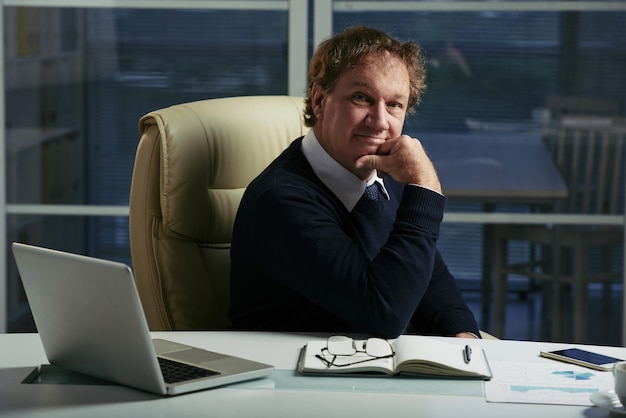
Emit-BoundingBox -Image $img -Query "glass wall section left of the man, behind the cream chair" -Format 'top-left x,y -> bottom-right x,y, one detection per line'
0,1 -> 306,331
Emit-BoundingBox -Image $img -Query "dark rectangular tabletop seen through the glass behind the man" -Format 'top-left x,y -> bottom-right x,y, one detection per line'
419,132 -> 567,201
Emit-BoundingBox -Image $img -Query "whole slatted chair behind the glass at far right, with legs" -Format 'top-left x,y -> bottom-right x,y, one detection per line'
493,116 -> 626,342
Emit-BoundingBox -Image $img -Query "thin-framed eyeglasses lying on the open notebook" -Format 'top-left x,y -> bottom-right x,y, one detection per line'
315,335 -> 395,367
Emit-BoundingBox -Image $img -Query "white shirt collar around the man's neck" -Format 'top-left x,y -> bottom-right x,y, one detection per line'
302,129 -> 389,212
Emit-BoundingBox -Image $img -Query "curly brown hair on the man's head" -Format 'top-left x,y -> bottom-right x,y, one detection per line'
304,26 -> 426,127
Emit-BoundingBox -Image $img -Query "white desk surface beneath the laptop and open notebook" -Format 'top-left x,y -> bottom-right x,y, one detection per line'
0,332 -> 626,418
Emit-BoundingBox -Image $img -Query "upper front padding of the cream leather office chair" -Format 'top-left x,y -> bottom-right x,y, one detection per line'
139,96 -> 308,242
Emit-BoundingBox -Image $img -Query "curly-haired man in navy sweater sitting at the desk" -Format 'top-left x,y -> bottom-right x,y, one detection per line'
230,27 -> 479,338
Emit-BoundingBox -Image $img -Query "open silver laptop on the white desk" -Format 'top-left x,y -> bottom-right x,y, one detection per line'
13,243 -> 274,395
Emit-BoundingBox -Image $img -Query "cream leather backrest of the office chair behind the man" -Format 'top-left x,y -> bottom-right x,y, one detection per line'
129,96 -> 307,330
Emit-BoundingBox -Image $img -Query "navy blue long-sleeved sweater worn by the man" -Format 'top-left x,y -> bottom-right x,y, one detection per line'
230,138 -> 478,338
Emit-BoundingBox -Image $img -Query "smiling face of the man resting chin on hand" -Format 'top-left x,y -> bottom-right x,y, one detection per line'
311,53 -> 409,180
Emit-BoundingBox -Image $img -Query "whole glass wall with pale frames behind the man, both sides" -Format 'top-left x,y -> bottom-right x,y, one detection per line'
0,0 -> 626,342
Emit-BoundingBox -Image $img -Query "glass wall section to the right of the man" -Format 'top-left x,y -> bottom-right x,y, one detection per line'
322,2 -> 626,342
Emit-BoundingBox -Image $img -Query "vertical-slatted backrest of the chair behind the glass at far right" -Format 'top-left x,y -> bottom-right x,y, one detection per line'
555,116 -> 626,214
